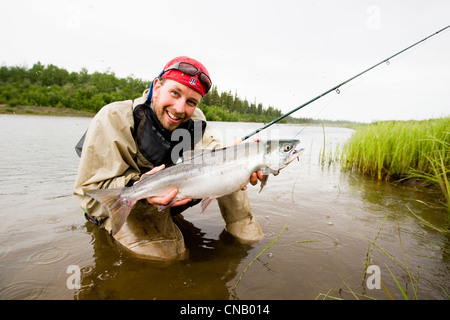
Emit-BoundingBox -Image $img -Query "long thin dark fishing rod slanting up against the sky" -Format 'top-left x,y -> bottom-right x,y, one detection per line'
242,25 -> 450,141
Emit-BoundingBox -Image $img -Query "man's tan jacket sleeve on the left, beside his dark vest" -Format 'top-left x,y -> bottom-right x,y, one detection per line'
74,101 -> 140,217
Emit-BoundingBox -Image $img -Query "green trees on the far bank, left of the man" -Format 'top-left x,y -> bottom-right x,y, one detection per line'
0,62 -> 150,112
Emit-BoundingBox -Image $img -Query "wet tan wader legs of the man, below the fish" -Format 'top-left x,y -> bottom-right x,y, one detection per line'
100,191 -> 263,261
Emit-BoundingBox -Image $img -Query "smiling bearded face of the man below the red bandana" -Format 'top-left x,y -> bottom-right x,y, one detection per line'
152,79 -> 202,131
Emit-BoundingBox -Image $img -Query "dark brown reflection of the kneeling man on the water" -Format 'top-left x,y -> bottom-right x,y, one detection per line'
74,215 -> 252,300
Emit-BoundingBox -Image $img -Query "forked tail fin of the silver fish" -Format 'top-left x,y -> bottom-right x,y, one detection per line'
86,188 -> 136,235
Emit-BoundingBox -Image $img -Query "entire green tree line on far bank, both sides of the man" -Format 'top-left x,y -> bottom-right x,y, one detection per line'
0,62 -> 281,122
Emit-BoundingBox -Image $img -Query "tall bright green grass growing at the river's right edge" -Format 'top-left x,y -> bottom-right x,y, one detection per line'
340,117 -> 450,219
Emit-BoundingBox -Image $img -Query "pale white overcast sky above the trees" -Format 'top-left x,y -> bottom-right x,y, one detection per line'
0,0 -> 450,122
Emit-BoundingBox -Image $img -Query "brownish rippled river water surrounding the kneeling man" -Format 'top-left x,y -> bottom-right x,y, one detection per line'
0,115 -> 450,300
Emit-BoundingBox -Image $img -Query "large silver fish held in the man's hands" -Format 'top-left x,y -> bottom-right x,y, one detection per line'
86,139 -> 304,235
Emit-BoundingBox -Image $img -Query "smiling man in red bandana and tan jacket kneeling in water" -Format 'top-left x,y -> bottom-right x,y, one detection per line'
74,57 -> 263,261
